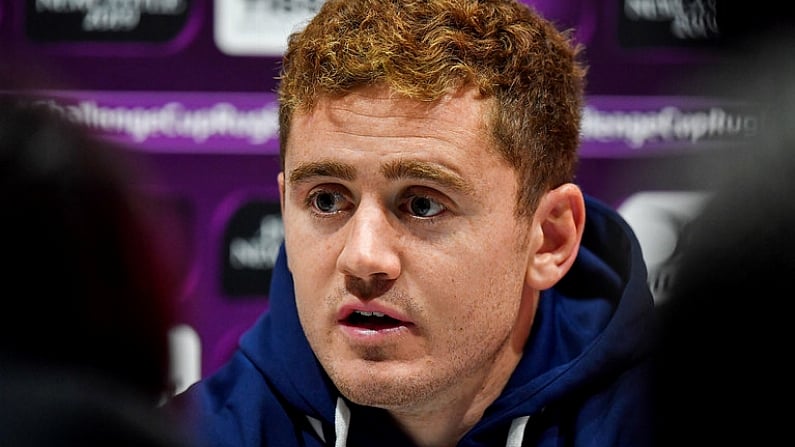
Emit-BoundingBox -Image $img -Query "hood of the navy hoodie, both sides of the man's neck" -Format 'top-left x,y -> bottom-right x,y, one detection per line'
240,196 -> 654,444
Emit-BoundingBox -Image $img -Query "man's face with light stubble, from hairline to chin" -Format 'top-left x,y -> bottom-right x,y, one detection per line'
279,84 -> 537,410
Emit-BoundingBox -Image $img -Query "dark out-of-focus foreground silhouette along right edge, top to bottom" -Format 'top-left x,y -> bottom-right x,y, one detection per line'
655,2 -> 795,447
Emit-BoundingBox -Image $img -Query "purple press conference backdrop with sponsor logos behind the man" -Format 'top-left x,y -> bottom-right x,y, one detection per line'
0,0 -> 761,391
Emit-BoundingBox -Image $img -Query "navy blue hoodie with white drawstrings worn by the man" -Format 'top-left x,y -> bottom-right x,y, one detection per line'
175,197 -> 655,447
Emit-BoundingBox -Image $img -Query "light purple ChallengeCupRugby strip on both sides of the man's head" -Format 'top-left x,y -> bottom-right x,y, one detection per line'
3,91 -> 763,158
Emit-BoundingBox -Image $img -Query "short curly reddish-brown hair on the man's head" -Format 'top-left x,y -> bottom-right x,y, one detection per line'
279,0 -> 587,216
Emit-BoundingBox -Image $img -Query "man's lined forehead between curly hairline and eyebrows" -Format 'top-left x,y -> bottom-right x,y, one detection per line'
286,87 -> 493,161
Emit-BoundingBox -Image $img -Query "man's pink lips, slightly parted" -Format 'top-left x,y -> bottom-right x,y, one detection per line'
337,301 -> 414,344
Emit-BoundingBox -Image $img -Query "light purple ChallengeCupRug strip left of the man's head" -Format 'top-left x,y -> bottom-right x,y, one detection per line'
3,91 -> 279,154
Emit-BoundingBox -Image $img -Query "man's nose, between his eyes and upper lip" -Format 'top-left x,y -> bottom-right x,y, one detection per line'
337,202 -> 401,280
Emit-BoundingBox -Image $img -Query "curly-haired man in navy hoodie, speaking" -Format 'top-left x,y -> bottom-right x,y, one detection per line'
181,0 -> 653,447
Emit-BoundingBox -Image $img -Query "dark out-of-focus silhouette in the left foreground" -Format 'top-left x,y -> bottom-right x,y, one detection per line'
0,95 -> 192,447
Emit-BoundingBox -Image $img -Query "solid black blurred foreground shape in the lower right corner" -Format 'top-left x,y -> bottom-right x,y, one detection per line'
657,150 -> 795,447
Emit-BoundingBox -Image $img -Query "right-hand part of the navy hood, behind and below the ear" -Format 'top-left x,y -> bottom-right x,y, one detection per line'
467,196 -> 656,438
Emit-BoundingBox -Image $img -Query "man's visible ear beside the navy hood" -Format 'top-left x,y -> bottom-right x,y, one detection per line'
526,183 -> 585,290
